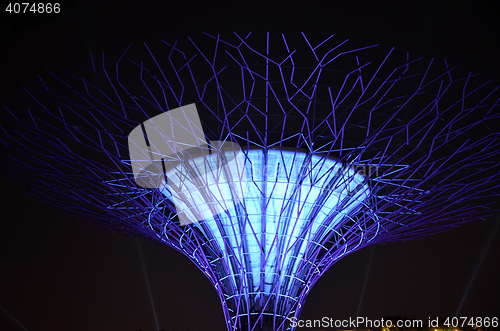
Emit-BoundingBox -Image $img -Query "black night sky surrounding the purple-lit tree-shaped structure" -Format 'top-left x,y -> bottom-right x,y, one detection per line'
0,1 -> 500,331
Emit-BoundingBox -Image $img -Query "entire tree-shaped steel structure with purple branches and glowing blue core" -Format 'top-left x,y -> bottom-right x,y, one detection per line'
2,34 -> 500,331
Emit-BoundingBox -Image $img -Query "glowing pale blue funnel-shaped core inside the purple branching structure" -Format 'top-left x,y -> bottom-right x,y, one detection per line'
163,149 -> 370,312
